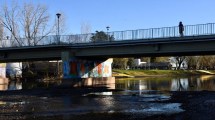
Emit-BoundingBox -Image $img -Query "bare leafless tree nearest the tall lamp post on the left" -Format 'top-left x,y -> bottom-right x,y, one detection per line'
20,3 -> 51,46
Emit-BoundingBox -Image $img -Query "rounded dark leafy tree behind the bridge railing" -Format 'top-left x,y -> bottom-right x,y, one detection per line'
91,31 -> 114,42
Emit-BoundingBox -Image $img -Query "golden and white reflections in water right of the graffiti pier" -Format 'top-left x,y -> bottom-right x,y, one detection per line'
116,75 -> 215,91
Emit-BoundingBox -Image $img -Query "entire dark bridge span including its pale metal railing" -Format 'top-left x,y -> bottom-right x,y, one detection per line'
0,23 -> 215,78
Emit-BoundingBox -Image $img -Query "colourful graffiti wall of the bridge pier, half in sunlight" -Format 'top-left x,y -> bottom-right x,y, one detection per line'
63,58 -> 112,78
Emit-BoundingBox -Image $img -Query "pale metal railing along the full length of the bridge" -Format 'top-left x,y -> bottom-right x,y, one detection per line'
0,23 -> 215,47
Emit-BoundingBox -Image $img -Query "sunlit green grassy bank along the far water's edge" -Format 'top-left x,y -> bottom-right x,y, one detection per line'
113,69 -> 215,77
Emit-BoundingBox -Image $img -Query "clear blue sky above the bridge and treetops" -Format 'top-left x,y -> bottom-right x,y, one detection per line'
0,0 -> 215,34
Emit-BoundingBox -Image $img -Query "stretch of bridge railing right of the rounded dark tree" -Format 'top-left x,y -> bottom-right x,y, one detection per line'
108,23 -> 215,40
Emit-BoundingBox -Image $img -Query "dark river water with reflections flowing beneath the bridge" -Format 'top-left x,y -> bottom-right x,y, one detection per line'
0,75 -> 215,119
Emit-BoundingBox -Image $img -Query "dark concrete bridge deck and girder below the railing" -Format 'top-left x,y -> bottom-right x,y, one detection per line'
0,35 -> 215,62
